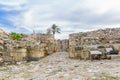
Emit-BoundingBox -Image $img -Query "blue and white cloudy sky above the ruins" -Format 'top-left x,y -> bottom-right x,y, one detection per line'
0,0 -> 120,39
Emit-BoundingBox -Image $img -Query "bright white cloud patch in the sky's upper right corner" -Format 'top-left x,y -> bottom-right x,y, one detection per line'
83,0 -> 120,14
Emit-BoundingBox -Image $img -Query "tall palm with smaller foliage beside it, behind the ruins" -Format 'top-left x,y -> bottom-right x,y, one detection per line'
47,24 -> 60,40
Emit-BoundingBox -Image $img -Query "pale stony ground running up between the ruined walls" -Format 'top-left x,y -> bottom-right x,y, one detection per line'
0,52 -> 120,80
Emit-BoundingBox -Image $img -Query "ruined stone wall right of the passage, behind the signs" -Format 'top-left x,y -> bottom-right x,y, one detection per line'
69,28 -> 120,60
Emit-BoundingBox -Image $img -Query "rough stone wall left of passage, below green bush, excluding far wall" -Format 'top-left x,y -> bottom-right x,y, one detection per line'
0,34 -> 53,62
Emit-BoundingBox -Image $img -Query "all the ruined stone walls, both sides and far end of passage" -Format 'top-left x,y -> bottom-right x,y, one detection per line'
0,28 -> 120,63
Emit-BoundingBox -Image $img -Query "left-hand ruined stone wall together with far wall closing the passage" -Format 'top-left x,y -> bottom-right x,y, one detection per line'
0,27 -> 69,63
